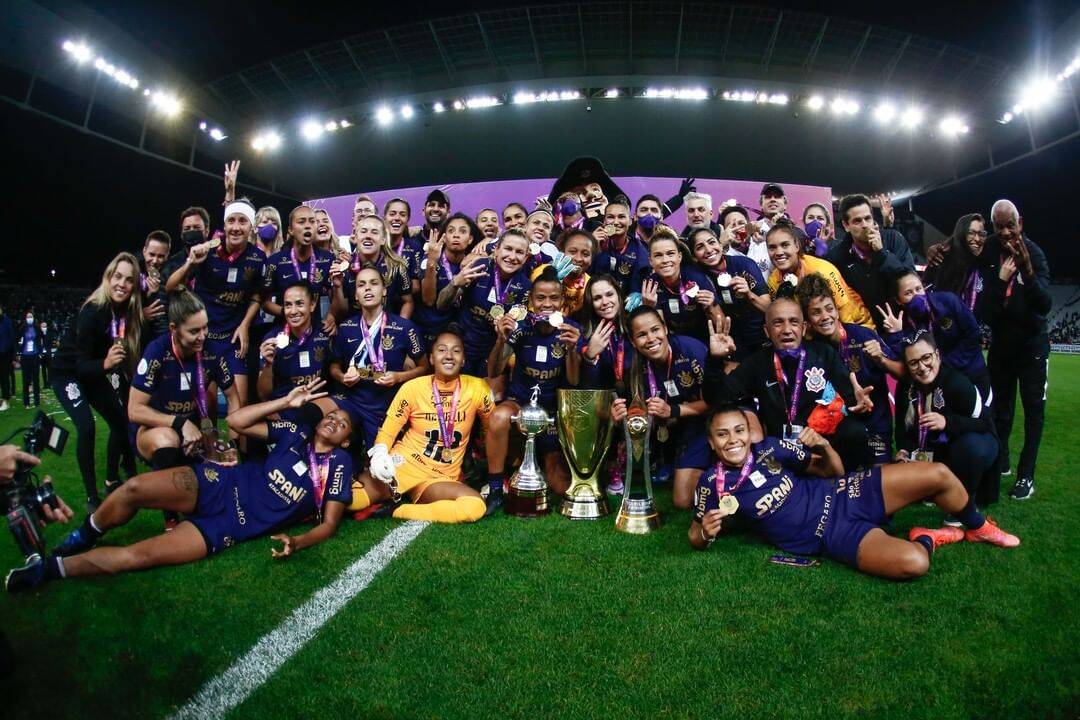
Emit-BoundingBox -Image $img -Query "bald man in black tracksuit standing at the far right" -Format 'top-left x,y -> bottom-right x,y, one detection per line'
975,200 -> 1052,505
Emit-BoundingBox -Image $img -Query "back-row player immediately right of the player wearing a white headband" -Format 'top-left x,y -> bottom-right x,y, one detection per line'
262,205 -> 348,332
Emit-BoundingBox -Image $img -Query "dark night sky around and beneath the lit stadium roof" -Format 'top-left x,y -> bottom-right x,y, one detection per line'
8,0 -> 1080,284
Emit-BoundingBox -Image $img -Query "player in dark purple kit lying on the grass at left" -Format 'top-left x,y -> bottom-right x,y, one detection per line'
5,380 -> 353,593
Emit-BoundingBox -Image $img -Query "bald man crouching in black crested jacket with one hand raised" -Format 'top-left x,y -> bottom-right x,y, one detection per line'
704,290 -> 873,473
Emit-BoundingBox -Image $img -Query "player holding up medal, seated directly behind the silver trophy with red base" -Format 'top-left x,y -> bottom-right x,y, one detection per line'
485,266 -> 581,514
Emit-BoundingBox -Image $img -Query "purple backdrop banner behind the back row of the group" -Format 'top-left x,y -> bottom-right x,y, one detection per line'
311,177 -> 832,235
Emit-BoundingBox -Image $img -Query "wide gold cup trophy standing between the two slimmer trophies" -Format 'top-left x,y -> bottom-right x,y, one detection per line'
556,390 -> 615,520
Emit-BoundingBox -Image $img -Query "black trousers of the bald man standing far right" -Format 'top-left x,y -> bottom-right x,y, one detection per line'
989,347 -> 1050,479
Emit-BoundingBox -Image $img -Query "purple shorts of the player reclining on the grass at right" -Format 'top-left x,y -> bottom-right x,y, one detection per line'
821,467 -> 892,568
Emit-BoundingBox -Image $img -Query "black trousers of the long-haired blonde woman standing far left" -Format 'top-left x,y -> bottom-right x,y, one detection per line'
52,372 -> 135,498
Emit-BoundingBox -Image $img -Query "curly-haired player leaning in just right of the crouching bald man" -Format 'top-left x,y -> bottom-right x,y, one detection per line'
795,273 -> 902,464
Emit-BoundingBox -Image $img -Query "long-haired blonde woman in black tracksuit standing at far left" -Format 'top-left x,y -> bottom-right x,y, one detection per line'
52,253 -> 143,512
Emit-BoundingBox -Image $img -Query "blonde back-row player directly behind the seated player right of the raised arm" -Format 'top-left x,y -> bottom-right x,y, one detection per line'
343,216 -> 414,318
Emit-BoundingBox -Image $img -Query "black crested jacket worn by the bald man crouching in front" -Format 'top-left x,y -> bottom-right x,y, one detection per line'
703,342 -> 855,437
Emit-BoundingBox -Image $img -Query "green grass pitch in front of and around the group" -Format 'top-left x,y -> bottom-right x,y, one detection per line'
0,355 -> 1080,720
